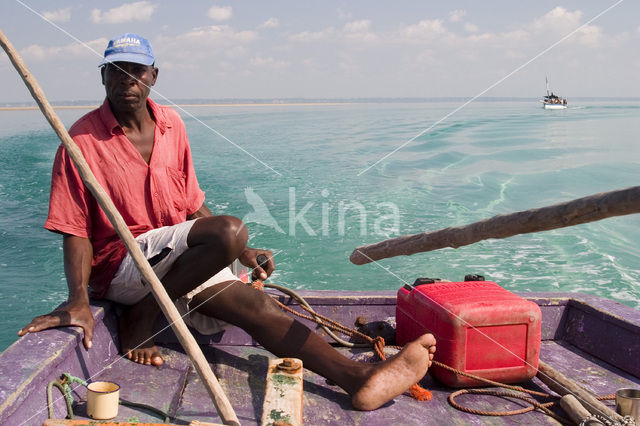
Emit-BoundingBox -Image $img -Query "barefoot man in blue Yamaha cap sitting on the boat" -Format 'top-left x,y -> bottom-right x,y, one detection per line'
18,34 -> 436,410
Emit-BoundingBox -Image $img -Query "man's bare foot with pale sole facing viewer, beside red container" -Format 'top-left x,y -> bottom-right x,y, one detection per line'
351,334 -> 436,411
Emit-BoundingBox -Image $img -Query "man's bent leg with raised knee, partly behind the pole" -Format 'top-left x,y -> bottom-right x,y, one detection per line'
120,216 -> 247,365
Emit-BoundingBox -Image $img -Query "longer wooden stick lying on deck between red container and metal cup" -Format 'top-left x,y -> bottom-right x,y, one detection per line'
536,361 -> 623,422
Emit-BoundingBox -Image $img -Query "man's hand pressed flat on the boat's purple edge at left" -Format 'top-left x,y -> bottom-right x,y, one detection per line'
18,303 -> 94,349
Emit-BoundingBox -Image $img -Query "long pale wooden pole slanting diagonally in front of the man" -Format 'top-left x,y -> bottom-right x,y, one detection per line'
0,30 -> 240,425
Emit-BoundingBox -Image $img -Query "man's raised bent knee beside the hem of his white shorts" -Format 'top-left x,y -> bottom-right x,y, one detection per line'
187,215 -> 248,263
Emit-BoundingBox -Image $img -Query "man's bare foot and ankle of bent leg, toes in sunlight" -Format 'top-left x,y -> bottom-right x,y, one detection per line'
119,305 -> 164,367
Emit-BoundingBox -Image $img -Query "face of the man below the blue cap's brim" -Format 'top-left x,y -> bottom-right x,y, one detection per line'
102,62 -> 158,111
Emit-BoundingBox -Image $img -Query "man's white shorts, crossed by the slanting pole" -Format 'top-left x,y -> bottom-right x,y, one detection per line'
105,220 -> 239,335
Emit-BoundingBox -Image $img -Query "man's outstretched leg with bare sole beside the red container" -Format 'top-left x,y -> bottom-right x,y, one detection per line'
190,281 -> 436,410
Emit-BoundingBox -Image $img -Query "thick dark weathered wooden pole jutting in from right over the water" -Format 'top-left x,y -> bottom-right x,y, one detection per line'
350,186 -> 640,265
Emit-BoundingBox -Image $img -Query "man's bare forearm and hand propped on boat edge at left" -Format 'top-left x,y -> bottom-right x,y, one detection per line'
18,234 -> 94,349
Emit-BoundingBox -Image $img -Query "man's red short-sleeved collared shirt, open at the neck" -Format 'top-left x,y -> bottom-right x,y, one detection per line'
44,99 -> 204,297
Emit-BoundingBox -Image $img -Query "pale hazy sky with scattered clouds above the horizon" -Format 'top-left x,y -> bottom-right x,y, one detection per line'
0,0 -> 640,104
